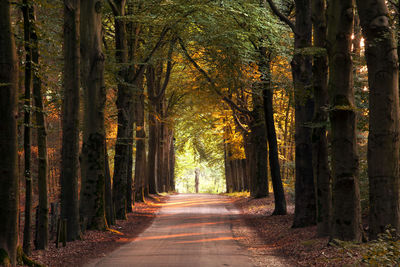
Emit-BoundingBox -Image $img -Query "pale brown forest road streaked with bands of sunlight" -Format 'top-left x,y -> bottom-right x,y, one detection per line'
86,194 -> 254,267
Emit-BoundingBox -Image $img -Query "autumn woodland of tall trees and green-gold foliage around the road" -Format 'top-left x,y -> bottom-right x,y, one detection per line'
0,0 -> 400,266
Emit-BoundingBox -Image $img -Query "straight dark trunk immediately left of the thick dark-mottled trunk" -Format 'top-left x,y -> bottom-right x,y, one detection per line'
60,0 -> 81,241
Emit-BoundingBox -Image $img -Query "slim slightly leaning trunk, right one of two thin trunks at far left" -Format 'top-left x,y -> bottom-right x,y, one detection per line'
30,4 -> 49,249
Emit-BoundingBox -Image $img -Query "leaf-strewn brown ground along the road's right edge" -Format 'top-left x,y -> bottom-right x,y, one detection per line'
233,195 -> 361,266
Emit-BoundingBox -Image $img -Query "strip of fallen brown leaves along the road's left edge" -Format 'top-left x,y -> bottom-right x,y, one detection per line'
22,196 -> 168,267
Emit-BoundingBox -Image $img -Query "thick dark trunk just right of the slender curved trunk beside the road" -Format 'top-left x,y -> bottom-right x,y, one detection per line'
291,0 -> 316,227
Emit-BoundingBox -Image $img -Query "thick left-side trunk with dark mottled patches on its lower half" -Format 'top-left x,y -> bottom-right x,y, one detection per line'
80,0 -> 107,229
